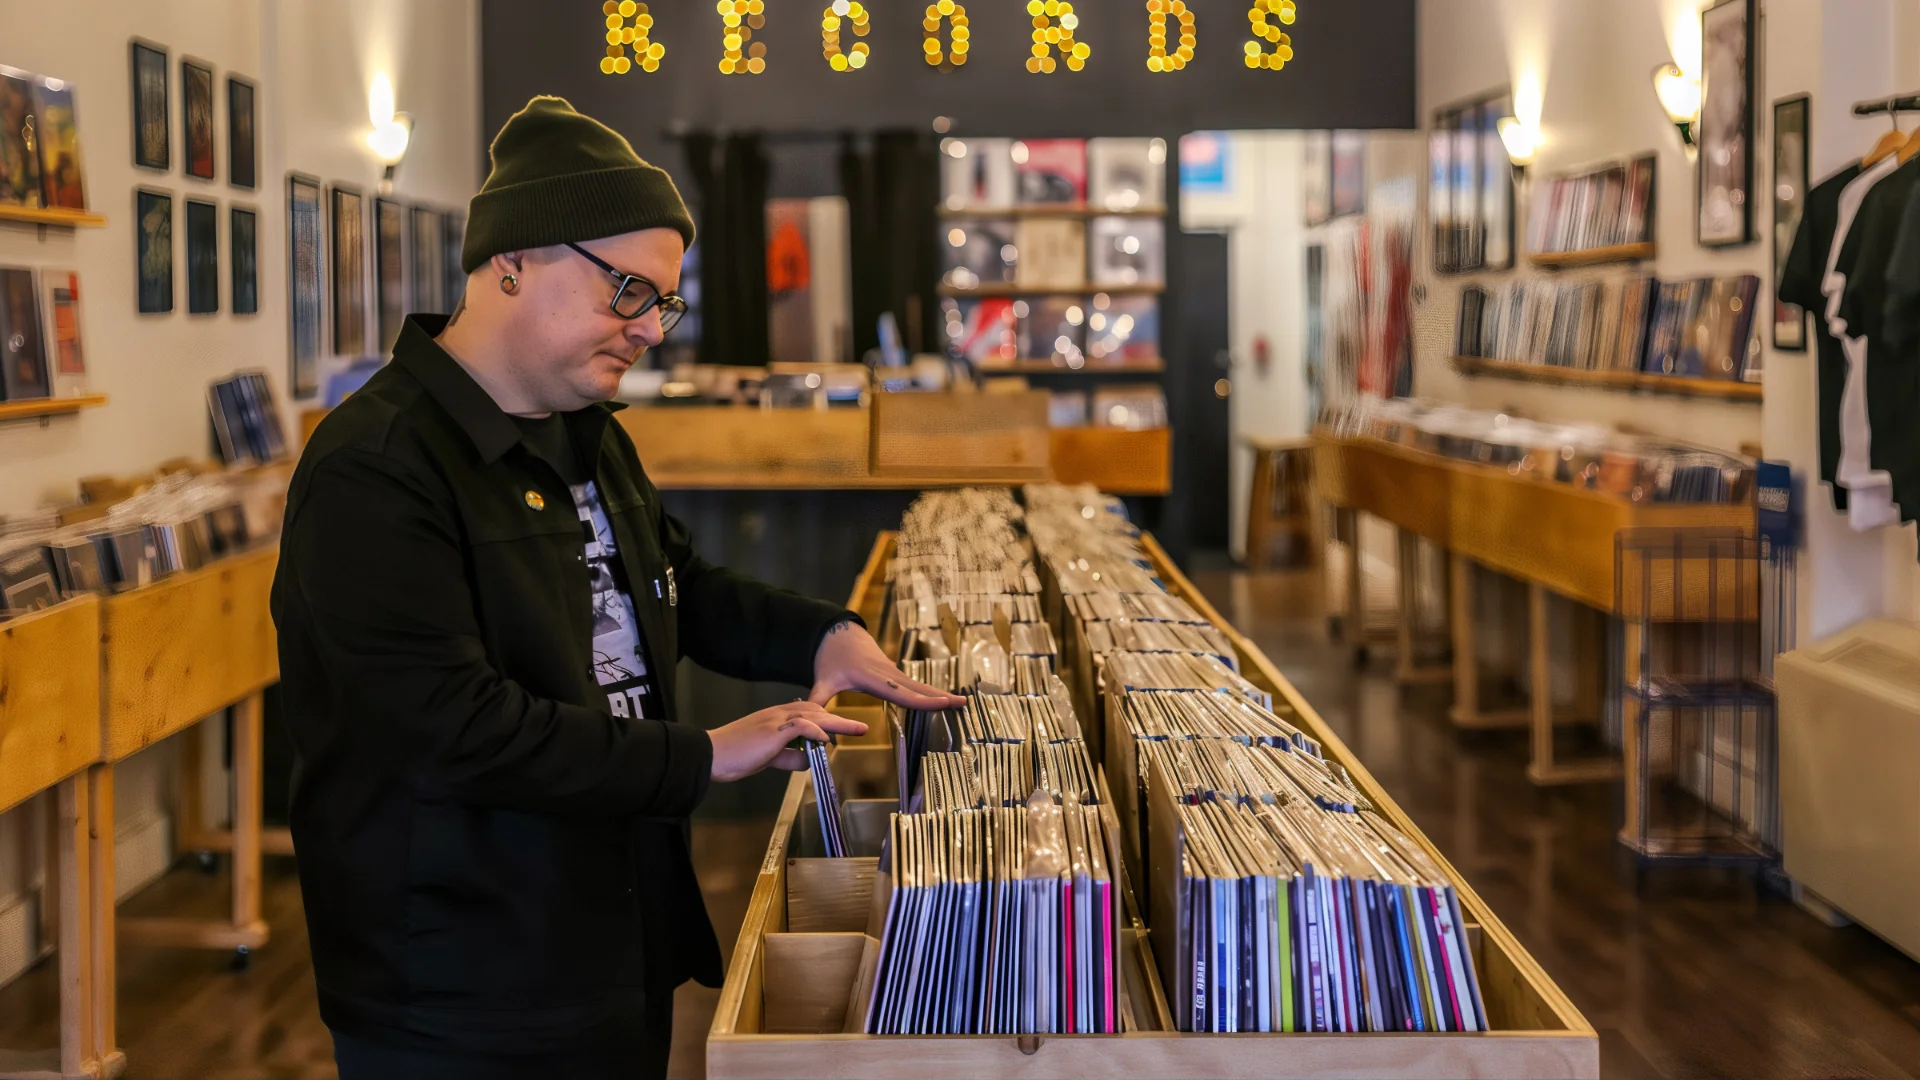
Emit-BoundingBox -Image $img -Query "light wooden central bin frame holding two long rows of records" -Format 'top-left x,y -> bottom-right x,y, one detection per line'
707,532 -> 1599,1080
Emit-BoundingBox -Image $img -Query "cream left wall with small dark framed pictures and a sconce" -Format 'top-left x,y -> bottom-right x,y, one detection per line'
0,0 -> 484,982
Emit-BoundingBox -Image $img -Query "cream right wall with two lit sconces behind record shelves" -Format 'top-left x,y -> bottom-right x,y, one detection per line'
1415,0 -> 1920,642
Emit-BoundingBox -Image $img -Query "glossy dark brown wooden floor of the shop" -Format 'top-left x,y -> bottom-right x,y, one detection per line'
11,573 -> 1920,1080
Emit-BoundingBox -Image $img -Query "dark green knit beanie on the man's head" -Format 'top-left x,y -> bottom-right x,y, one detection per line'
461,96 -> 693,273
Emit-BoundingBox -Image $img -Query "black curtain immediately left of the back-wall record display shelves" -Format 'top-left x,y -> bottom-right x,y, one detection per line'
839,131 -> 941,356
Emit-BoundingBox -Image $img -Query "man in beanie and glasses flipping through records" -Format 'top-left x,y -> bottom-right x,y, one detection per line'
273,98 -> 958,1080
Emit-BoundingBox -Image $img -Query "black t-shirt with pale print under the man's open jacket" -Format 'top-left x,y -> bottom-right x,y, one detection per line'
515,415 -> 666,719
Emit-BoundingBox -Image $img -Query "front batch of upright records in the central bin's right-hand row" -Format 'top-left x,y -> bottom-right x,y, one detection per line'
1150,742 -> 1488,1032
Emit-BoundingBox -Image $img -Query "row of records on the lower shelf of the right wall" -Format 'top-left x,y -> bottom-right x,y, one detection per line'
1453,275 -> 1761,380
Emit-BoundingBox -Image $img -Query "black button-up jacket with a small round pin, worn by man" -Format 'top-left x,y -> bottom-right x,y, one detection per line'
273,317 -> 852,1055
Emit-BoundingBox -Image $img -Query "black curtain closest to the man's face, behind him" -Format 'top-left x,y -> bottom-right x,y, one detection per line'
682,133 -> 772,367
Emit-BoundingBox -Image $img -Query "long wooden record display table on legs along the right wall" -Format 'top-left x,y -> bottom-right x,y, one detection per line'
1313,432 -> 1755,784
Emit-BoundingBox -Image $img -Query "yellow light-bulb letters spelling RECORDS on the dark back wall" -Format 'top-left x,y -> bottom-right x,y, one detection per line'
599,0 -> 1298,75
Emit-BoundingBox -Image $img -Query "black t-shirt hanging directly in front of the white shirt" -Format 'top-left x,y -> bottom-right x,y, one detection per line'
1837,158 -> 1920,521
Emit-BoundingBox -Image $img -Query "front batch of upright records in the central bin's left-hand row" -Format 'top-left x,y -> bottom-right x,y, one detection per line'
862,792 -> 1121,1036
